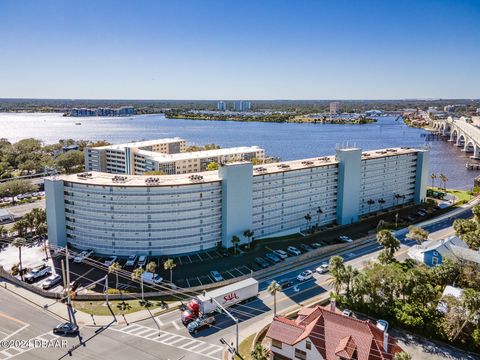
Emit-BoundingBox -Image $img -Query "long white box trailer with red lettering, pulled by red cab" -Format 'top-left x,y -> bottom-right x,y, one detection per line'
197,278 -> 258,314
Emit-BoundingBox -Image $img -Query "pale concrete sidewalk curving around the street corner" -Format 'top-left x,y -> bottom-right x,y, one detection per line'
0,279 -> 180,327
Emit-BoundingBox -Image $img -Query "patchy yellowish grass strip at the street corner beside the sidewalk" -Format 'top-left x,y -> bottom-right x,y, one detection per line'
73,298 -> 171,315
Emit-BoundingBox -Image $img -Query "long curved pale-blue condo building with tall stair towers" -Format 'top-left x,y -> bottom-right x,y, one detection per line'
45,148 -> 429,255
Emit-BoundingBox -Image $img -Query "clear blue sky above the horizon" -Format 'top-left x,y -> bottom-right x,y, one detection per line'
0,0 -> 480,100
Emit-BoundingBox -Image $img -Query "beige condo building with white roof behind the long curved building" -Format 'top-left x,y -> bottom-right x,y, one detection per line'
85,138 -> 265,175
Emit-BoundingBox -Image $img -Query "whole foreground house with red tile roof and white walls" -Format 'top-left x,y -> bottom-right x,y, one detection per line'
266,306 -> 402,360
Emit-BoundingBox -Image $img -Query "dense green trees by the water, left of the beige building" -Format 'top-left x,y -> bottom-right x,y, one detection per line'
0,138 -> 108,179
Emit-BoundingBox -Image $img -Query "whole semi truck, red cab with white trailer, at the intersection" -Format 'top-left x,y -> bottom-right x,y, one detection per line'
180,278 -> 258,325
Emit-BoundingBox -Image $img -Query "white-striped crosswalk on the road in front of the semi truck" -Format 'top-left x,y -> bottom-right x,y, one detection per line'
111,324 -> 223,360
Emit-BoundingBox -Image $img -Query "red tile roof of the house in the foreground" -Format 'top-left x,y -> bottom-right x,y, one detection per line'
266,306 -> 402,360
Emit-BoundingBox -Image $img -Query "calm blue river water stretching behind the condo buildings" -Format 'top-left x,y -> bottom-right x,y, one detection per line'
0,113 -> 479,189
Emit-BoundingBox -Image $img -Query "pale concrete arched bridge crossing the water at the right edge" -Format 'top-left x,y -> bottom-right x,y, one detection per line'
430,117 -> 480,159
